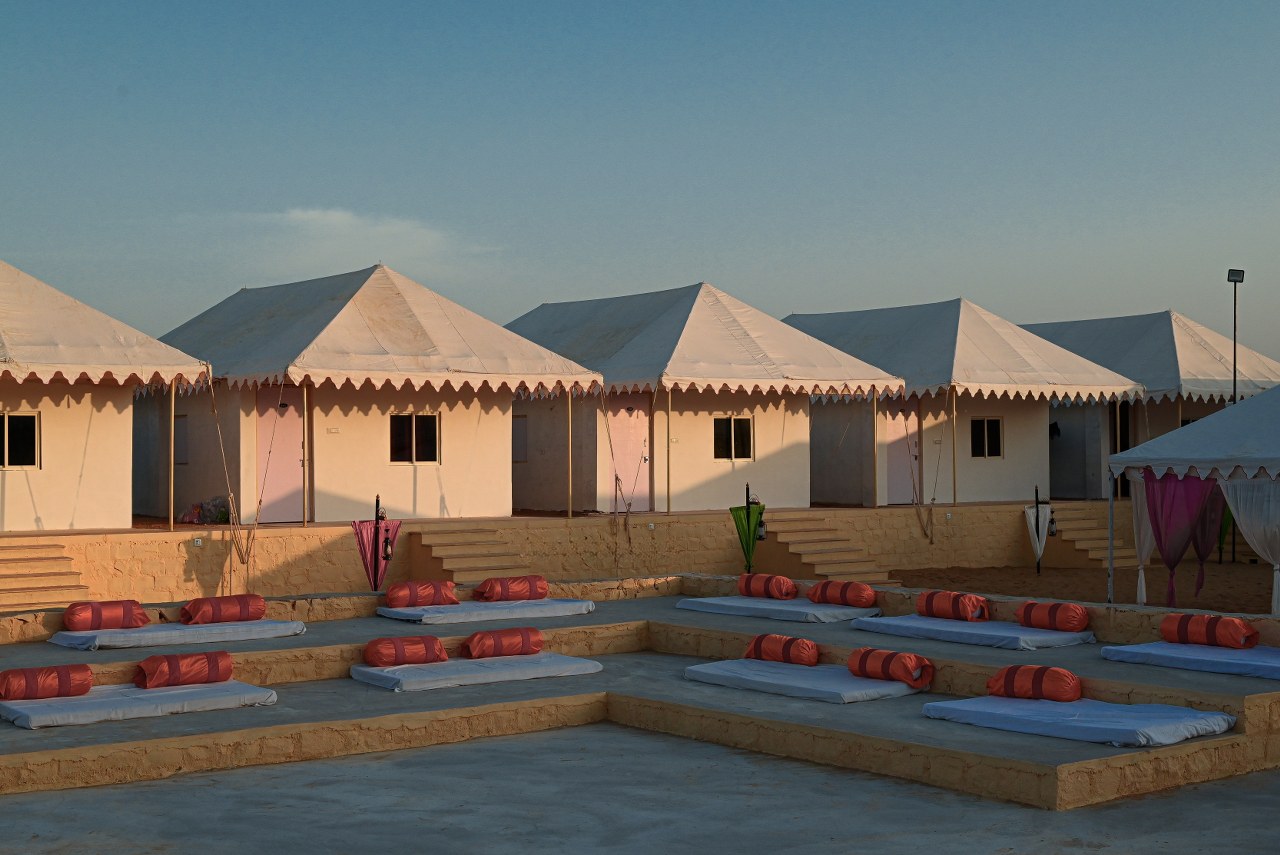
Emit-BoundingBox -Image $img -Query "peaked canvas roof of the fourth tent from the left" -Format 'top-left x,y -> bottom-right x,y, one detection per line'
783,300 -> 1142,401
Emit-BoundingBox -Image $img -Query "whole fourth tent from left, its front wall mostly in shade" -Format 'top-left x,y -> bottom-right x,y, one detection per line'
785,300 -> 1140,503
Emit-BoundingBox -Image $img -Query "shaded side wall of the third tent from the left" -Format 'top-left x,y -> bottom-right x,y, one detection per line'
511,394 -> 601,513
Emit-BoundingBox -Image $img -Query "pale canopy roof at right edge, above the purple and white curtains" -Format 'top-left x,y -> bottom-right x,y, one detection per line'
1108,381 -> 1280,479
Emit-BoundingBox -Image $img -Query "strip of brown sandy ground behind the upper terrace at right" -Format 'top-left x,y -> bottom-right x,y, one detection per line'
893,557 -> 1271,614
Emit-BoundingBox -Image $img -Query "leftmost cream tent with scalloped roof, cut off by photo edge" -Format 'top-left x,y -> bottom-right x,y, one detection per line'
0,261 -> 204,531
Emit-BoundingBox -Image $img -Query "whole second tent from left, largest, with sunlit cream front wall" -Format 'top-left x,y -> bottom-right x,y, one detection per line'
156,265 -> 600,522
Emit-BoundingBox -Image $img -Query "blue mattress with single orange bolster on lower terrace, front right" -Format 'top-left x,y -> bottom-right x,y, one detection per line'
920,695 -> 1235,747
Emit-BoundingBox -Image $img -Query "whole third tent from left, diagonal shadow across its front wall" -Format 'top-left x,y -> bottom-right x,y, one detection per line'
507,283 -> 902,511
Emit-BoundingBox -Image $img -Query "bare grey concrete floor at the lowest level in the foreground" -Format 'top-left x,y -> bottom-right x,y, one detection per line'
0,724 -> 1280,855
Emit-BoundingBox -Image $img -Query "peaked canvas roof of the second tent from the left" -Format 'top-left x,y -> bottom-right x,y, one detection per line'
164,265 -> 600,390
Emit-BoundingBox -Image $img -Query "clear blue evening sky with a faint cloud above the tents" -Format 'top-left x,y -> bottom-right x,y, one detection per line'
0,0 -> 1280,357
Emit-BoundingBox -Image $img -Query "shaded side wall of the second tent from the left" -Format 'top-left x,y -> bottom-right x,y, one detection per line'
168,383 -> 248,522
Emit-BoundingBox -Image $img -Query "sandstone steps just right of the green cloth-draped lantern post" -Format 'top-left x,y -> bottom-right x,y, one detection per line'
754,511 -> 895,585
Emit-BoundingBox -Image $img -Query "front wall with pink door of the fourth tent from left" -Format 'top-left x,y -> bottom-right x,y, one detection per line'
920,394 -> 1050,504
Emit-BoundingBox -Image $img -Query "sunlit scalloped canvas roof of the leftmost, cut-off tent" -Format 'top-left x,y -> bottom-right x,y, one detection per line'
0,261 -> 205,385
